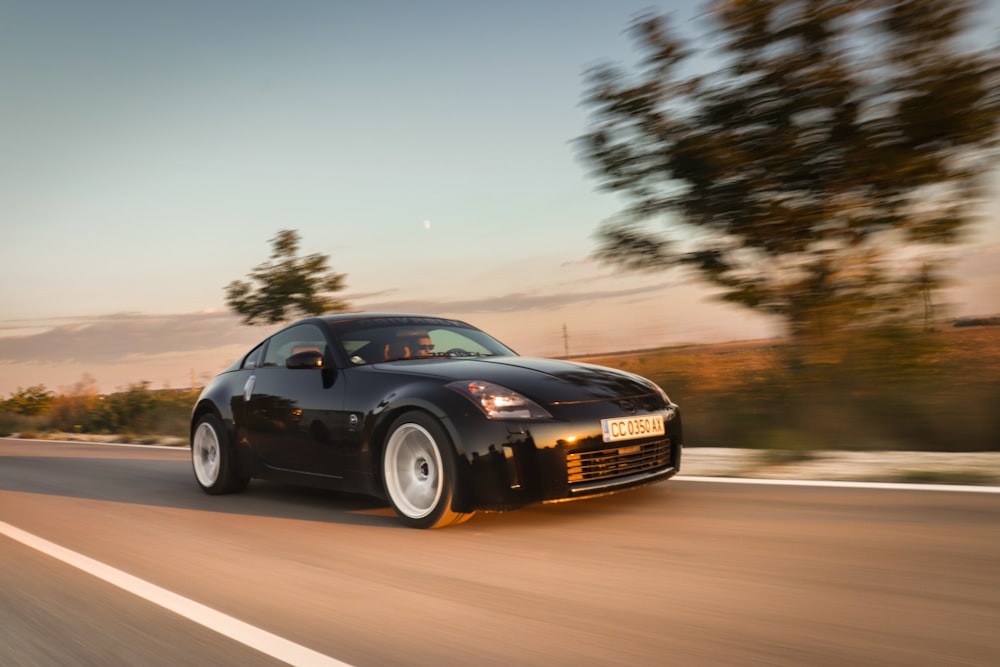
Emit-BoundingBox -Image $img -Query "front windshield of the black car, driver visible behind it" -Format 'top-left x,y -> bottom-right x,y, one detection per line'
337,318 -> 515,365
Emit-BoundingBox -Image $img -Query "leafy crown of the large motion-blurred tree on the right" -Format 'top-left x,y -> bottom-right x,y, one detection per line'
579,0 -> 1000,339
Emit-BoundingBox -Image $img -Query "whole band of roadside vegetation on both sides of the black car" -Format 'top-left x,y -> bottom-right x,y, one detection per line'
0,320 -> 1000,455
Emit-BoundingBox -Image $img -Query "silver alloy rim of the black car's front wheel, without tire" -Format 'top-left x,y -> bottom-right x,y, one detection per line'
383,423 -> 443,519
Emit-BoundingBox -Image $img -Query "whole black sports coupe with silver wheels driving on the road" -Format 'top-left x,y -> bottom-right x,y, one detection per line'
191,314 -> 681,528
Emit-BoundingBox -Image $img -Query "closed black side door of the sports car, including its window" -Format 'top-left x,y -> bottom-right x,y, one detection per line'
243,323 -> 345,478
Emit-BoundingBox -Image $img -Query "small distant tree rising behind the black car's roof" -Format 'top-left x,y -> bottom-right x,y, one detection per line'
226,229 -> 347,324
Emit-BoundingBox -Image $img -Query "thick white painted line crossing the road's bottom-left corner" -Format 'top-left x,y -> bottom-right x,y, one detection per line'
0,521 -> 351,667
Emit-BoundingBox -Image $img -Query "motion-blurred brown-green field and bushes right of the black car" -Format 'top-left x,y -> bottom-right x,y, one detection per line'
586,326 -> 1000,455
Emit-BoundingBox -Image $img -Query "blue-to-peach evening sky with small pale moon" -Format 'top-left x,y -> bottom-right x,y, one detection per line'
0,0 -> 1000,398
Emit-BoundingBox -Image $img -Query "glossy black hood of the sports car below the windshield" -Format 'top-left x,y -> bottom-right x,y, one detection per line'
379,357 -> 657,405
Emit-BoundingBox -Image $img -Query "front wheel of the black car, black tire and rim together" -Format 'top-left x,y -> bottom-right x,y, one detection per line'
382,411 -> 474,528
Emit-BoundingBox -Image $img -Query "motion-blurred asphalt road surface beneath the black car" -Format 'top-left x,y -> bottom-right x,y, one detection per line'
0,439 -> 1000,667
